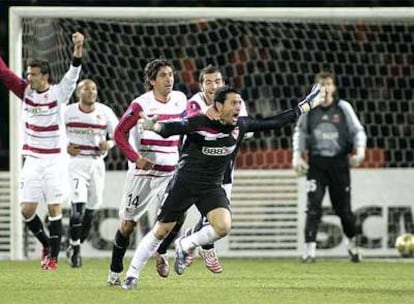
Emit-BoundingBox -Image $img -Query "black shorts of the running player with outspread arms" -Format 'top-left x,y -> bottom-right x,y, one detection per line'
157,175 -> 230,223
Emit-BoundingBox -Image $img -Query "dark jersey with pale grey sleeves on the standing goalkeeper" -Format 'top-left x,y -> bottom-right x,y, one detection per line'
293,100 -> 367,157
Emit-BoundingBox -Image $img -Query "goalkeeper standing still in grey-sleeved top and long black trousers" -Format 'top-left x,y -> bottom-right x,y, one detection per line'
292,72 -> 367,263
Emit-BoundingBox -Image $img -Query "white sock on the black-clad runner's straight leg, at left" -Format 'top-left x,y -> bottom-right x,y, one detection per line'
126,231 -> 162,278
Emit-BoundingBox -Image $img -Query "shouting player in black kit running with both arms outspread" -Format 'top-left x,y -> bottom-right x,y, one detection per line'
122,87 -> 321,289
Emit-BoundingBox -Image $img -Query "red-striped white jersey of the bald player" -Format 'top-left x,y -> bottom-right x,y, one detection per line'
65,102 -> 118,157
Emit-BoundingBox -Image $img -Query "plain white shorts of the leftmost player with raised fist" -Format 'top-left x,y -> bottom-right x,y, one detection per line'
19,156 -> 69,204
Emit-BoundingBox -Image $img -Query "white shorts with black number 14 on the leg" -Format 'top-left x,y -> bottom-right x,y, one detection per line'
119,170 -> 173,222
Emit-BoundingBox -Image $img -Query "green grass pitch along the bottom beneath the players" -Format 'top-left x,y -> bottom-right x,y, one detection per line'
0,259 -> 414,304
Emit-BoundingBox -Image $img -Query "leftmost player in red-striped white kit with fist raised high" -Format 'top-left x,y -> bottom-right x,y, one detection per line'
0,33 -> 84,270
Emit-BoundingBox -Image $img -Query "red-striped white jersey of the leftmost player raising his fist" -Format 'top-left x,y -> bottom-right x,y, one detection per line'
0,58 -> 81,158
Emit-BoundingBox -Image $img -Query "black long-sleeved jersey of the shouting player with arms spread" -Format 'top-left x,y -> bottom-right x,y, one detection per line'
160,109 -> 300,188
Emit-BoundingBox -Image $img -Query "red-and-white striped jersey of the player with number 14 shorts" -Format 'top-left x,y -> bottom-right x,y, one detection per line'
115,91 -> 187,177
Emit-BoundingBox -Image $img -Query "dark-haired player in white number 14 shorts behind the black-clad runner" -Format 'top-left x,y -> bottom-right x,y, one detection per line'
108,59 -> 187,286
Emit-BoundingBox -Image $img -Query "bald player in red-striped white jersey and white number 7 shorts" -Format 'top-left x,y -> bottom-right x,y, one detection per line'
65,79 -> 118,267
